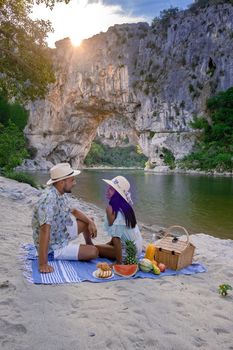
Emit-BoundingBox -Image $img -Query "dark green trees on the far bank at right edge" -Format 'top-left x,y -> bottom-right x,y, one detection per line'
180,87 -> 233,172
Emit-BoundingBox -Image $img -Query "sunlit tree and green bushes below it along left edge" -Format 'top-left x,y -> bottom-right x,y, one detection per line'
0,0 -> 70,186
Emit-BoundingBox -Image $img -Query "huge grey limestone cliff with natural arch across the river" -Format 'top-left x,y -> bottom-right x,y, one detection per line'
25,5 -> 233,167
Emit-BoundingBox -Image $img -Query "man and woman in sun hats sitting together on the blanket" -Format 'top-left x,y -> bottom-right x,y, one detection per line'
32,163 -> 142,273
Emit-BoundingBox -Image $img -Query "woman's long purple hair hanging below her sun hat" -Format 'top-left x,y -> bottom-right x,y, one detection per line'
109,191 -> 137,228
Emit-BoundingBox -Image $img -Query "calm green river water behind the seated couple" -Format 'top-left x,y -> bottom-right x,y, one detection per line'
33,169 -> 233,239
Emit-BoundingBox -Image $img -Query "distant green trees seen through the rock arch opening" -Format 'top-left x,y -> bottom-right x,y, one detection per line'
84,141 -> 147,168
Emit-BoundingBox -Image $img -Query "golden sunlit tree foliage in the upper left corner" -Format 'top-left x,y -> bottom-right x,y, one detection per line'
0,0 -> 69,101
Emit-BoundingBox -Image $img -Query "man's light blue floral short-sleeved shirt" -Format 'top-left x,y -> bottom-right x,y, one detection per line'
32,186 -> 73,253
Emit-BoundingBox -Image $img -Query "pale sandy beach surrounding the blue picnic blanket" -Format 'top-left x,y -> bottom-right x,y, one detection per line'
0,177 -> 233,350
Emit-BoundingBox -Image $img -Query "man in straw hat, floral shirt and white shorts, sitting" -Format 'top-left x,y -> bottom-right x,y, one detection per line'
32,163 -> 98,273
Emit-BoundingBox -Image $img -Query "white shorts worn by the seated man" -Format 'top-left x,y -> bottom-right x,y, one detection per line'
54,215 -> 80,260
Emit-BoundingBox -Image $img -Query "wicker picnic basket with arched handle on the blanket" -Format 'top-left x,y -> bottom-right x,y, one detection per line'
155,226 -> 195,270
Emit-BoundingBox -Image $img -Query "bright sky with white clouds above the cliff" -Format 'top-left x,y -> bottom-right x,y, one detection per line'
31,0 -> 193,47
